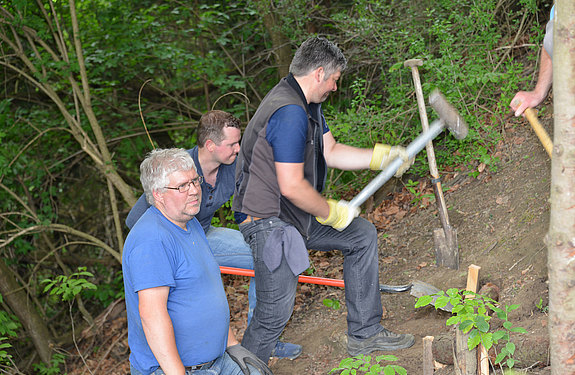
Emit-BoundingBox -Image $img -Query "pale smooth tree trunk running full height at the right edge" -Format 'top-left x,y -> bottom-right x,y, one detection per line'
546,0 -> 575,375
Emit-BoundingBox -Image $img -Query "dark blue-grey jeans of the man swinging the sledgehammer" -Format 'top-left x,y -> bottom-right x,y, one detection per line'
240,217 -> 383,362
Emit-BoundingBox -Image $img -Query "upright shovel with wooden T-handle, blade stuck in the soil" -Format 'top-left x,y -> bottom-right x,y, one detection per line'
403,59 -> 459,269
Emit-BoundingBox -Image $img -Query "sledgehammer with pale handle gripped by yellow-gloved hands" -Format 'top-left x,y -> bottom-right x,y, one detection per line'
349,89 -> 468,207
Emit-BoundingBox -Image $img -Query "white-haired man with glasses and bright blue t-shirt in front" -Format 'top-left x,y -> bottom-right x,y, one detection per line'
122,149 -> 271,375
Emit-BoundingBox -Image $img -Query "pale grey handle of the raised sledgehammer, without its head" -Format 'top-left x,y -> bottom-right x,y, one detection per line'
349,120 -> 445,207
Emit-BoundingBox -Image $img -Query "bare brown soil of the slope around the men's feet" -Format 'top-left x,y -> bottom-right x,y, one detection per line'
67,112 -> 551,375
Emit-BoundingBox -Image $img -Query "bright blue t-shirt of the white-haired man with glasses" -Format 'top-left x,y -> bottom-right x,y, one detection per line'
122,207 -> 230,375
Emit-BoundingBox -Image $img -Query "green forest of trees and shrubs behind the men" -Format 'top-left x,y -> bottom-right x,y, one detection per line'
0,0 -> 552,373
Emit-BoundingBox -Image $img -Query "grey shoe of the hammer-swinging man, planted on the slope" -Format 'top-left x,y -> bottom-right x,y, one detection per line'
347,328 -> 415,357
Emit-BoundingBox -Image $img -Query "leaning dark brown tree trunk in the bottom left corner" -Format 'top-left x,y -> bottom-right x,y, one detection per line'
0,261 -> 54,363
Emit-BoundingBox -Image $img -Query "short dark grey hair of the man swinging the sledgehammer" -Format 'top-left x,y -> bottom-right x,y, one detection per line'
289,37 -> 347,79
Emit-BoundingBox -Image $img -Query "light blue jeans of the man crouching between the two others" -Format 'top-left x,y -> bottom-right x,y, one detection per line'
206,226 -> 257,324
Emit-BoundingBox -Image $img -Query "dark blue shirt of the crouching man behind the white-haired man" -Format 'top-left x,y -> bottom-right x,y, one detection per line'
126,146 -> 237,233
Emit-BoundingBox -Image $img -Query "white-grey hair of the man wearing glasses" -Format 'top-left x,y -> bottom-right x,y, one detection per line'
140,148 -> 197,206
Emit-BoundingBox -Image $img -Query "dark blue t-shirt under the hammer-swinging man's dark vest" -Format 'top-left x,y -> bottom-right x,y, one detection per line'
266,104 -> 329,163
